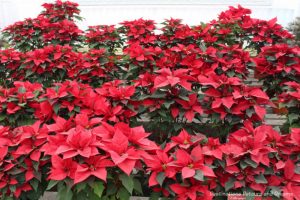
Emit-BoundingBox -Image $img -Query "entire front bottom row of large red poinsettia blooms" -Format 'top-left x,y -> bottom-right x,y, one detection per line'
0,106 -> 300,199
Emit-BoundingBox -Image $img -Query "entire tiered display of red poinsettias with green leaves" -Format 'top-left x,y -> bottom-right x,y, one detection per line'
0,0 -> 300,200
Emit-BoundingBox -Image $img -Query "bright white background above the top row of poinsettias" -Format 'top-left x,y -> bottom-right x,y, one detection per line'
0,0 -> 300,29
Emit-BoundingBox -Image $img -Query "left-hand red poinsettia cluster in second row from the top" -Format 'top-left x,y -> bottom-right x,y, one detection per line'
0,45 -> 114,86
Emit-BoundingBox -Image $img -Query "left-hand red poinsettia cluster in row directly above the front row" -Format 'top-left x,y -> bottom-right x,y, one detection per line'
0,81 -> 135,125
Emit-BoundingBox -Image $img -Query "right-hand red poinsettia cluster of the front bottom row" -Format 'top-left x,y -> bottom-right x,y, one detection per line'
146,124 -> 300,199
